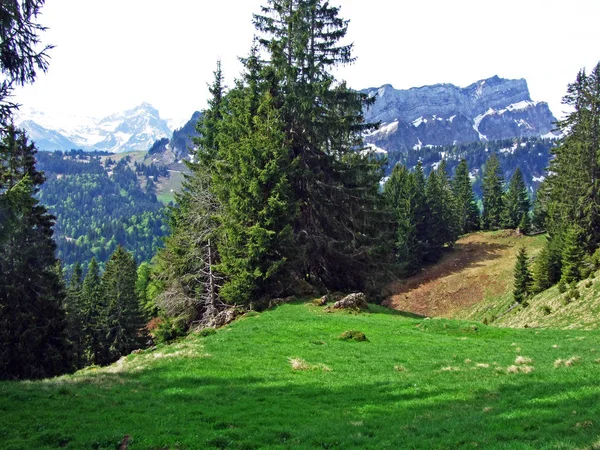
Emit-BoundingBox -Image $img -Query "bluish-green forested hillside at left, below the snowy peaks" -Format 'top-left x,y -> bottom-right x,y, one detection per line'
37,151 -> 168,271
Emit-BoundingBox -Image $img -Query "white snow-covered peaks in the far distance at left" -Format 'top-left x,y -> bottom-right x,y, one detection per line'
15,103 -> 173,153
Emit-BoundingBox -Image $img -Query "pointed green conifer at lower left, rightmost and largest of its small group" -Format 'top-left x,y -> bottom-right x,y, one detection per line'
100,245 -> 145,364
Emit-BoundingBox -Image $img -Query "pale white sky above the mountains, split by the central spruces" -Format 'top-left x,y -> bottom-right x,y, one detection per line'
15,0 -> 600,125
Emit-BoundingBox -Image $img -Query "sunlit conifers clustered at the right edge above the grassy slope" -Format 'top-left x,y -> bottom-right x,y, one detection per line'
515,63 -> 600,301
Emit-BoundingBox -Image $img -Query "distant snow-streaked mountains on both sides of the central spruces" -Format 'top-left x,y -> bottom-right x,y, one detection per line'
17,76 -> 556,157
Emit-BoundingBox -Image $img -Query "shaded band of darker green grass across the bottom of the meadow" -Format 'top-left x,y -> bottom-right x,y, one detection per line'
7,367 -> 600,449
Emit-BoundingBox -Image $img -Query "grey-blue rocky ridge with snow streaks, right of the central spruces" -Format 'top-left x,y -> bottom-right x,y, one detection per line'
361,76 -> 556,153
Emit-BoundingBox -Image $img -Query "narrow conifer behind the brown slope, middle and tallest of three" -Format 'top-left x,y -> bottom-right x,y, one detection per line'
481,154 -> 504,230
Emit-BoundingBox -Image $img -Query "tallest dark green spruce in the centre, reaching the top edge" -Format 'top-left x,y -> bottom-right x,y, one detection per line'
248,0 -> 388,290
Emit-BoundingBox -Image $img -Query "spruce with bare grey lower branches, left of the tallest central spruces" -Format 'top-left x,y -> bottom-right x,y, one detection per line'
151,62 -> 227,329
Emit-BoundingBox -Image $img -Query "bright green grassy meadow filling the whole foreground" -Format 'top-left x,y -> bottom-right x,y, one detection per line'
0,303 -> 600,450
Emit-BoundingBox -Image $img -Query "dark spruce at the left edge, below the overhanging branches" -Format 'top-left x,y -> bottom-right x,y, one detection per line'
0,126 -> 71,379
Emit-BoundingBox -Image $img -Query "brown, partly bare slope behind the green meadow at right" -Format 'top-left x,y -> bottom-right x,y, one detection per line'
386,231 -> 545,321
